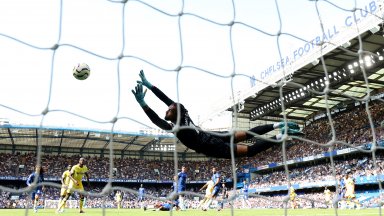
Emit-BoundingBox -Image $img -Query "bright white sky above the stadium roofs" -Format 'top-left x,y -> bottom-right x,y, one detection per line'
0,0 -> 377,131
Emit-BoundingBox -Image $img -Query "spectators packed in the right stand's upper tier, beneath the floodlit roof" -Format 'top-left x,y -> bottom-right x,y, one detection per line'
240,103 -> 384,170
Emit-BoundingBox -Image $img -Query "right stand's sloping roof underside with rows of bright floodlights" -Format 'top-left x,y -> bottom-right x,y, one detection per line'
228,29 -> 384,121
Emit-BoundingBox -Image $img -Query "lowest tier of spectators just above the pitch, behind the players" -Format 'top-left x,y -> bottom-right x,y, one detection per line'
0,181 -> 384,209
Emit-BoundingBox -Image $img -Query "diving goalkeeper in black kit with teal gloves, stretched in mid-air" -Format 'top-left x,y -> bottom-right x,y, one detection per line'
132,71 -> 302,159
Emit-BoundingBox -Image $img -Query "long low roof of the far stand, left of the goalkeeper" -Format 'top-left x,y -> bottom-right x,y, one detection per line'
0,125 -> 187,152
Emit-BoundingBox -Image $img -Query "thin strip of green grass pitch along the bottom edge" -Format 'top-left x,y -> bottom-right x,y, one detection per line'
0,209 -> 384,216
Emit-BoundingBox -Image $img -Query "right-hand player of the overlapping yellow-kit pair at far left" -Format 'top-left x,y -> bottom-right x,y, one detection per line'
56,158 -> 89,213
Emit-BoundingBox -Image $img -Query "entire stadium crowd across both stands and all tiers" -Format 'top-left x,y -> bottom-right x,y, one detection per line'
0,100 -> 384,208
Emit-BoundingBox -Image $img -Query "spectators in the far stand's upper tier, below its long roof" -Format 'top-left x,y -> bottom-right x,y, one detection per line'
0,153 -> 232,181
